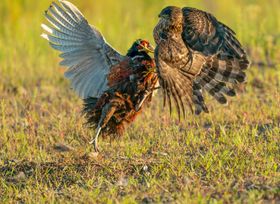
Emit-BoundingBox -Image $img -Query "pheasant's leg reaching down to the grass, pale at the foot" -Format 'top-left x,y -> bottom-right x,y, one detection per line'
90,103 -> 117,152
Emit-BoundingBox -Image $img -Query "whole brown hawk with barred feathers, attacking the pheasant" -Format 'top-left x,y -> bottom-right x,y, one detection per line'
154,6 -> 249,117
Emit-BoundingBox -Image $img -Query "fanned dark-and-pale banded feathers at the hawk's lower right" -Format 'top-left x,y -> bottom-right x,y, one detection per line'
193,54 -> 249,114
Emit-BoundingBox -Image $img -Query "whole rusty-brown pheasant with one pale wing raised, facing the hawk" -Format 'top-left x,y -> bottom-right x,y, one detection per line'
42,1 -> 157,151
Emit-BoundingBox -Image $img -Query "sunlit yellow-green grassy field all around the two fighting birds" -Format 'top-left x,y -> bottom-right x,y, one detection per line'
0,0 -> 280,203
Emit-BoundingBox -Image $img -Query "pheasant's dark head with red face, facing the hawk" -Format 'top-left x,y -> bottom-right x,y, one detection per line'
127,39 -> 154,57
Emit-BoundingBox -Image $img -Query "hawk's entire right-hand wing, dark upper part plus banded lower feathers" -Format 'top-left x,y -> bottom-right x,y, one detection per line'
182,7 -> 249,114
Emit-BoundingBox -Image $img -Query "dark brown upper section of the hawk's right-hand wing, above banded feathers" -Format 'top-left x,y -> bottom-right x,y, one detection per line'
182,7 -> 245,59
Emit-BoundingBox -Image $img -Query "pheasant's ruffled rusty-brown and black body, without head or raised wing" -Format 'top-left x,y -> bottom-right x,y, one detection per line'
84,53 -> 157,136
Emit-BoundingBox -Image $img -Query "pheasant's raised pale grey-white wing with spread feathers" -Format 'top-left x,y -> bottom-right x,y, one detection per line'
41,0 -> 124,99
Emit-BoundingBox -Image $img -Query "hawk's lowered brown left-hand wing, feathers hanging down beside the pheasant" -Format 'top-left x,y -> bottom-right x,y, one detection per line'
155,42 -> 207,118
